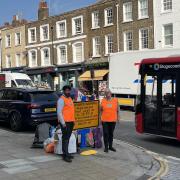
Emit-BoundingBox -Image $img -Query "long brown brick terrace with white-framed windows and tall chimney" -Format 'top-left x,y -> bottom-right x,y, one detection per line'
0,0 -> 154,89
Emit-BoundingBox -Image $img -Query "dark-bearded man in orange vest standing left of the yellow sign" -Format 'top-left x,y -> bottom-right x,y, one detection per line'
57,86 -> 75,162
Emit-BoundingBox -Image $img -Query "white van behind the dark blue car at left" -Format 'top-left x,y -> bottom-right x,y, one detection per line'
0,72 -> 35,88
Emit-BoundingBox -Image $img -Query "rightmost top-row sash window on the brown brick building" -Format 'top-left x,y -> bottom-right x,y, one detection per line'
139,0 -> 148,19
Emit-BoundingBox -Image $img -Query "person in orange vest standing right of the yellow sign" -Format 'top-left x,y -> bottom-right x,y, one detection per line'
101,89 -> 120,153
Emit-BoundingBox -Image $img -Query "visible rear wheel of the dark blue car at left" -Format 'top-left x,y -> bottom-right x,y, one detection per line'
10,112 -> 22,132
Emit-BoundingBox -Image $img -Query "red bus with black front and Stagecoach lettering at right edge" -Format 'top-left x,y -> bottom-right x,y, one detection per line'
136,57 -> 180,140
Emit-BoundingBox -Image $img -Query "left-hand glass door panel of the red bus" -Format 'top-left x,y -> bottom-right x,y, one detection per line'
142,74 -> 159,134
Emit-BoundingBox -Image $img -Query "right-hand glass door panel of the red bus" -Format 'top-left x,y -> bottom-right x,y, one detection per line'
158,73 -> 177,137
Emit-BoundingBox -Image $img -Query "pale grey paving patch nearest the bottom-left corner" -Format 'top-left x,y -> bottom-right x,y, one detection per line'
2,165 -> 38,174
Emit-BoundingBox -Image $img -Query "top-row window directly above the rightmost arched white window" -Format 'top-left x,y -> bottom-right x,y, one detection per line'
72,16 -> 83,35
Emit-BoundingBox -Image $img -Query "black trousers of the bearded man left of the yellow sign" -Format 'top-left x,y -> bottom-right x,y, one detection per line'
61,122 -> 74,156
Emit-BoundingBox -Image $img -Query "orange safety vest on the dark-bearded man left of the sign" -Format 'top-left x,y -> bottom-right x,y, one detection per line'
61,96 -> 75,122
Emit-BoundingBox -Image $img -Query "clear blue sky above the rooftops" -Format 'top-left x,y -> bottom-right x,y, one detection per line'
0,0 -> 97,26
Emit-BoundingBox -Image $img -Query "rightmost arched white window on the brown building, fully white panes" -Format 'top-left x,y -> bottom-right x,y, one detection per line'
73,42 -> 84,63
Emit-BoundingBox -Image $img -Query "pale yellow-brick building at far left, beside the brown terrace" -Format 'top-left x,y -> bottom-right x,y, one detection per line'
1,15 -> 27,71
